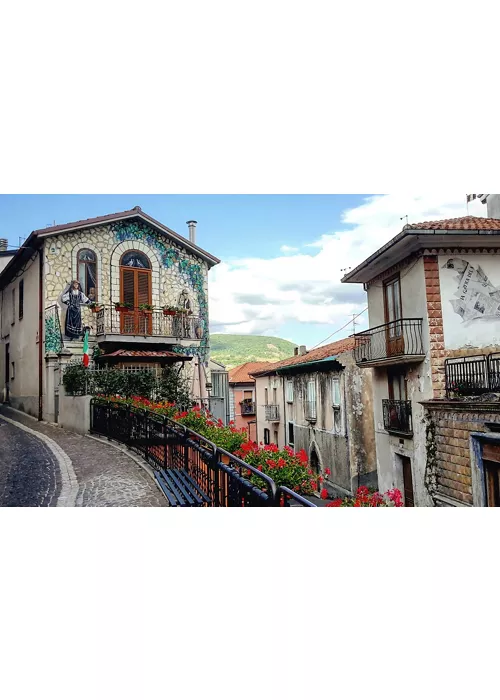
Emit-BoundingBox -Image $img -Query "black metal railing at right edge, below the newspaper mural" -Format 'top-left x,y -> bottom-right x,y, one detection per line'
444,353 -> 500,397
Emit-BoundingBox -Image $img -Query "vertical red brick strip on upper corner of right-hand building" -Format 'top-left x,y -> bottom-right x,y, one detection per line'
424,255 -> 446,399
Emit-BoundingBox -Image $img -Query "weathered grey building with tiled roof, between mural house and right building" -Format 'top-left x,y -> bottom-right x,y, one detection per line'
252,338 -> 377,496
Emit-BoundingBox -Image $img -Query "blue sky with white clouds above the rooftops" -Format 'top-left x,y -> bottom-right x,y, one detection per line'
0,193 -> 486,348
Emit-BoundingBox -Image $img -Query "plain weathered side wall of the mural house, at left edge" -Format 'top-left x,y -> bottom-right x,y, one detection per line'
0,250 -> 42,416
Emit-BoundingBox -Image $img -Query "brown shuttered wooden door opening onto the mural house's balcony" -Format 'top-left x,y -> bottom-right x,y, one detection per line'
120,267 -> 152,335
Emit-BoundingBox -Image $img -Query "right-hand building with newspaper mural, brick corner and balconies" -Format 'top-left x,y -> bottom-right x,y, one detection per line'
343,211 -> 500,506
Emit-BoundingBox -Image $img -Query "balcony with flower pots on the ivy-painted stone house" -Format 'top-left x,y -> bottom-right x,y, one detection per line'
82,305 -> 204,343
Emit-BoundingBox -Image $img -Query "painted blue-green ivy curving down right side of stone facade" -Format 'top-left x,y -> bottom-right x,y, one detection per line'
111,221 -> 209,362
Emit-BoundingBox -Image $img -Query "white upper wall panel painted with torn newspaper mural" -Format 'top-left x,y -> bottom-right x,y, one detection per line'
439,255 -> 500,350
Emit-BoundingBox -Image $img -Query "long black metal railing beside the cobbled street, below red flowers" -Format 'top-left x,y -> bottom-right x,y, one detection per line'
90,399 -> 316,508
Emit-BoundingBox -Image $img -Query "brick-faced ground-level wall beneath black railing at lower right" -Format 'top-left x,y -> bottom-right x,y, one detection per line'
426,402 -> 500,506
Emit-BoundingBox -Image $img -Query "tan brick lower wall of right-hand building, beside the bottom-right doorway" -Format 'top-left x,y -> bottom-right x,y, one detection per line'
426,403 -> 500,505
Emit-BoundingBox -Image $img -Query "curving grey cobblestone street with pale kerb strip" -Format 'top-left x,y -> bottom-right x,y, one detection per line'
0,406 -> 167,507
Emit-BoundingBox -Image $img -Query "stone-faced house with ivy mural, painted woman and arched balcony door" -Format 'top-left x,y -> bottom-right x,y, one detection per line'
0,207 -> 219,420
